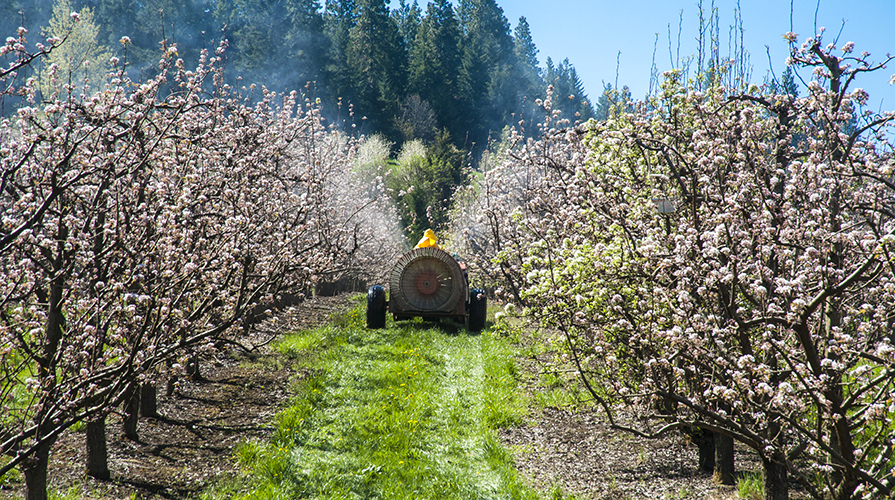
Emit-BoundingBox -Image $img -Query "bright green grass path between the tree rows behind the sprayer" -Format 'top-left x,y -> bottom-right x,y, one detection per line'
222,296 -> 539,500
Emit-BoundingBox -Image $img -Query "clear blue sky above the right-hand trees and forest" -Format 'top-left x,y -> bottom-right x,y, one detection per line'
496,0 -> 895,110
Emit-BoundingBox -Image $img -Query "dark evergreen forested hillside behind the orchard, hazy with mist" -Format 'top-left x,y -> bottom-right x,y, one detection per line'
0,0 -> 593,151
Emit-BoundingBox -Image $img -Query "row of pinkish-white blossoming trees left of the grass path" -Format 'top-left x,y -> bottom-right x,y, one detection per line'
0,28 -> 398,499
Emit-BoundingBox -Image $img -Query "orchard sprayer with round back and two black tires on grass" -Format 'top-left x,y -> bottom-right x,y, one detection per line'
367,246 -> 488,332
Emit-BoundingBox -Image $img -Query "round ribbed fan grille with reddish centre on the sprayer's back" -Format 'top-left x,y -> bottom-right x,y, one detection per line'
392,248 -> 465,312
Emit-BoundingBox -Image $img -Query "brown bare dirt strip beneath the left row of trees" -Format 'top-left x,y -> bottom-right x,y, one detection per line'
0,295 -> 349,500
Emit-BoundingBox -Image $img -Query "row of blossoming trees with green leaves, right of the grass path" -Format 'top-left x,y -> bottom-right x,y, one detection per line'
463,34 -> 895,500
